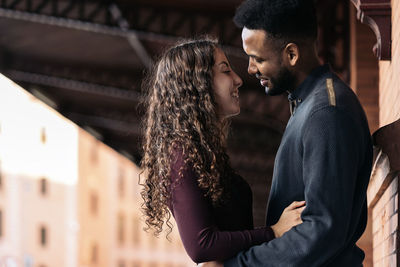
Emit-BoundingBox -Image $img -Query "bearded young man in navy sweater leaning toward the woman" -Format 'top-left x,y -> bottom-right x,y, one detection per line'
206,0 -> 372,267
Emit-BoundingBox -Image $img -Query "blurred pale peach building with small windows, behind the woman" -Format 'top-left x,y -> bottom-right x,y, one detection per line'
0,76 -> 194,267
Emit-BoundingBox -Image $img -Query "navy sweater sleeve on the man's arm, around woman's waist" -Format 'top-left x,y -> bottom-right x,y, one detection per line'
224,107 -> 366,267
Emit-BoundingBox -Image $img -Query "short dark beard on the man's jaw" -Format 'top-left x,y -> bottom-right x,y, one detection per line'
265,67 -> 295,96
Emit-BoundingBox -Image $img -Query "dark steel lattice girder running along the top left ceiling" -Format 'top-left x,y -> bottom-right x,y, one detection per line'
0,0 -> 241,47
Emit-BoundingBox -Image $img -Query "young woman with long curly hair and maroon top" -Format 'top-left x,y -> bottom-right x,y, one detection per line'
142,39 -> 304,263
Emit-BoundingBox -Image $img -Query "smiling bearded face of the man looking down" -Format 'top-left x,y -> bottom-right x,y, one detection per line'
242,28 -> 295,95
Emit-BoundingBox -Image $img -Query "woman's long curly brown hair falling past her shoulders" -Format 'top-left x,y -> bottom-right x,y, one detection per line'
141,38 -> 233,239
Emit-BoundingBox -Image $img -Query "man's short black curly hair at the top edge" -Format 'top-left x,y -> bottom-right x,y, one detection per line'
234,0 -> 317,42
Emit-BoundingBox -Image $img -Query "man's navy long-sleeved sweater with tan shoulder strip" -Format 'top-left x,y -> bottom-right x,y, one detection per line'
224,66 -> 372,267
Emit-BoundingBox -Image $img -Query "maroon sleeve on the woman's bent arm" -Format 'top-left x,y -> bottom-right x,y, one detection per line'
170,150 -> 274,263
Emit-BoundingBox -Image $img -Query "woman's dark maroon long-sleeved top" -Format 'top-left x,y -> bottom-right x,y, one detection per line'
169,152 -> 274,263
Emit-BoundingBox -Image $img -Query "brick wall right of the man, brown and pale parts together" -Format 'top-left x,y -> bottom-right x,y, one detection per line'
350,0 -> 400,267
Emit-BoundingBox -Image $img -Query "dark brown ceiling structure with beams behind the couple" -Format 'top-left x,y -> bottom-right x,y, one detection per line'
0,0 -> 349,225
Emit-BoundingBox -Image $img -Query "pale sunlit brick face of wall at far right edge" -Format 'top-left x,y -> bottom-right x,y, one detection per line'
366,0 -> 400,267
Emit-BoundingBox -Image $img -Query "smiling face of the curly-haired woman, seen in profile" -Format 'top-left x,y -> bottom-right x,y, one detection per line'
212,48 -> 242,119
